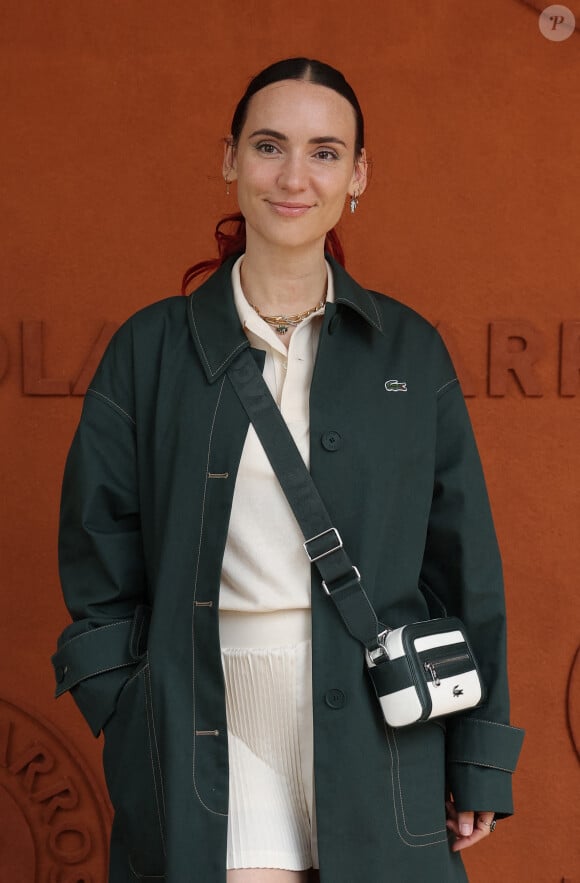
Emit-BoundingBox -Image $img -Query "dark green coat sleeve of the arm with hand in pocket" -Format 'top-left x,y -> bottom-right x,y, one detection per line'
52,328 -> 148,736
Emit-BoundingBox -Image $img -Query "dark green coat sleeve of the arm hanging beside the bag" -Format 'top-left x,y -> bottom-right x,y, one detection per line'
422,372 -> 523,817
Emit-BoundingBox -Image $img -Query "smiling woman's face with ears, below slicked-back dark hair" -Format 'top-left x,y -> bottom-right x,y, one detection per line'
224,80 -> 366,249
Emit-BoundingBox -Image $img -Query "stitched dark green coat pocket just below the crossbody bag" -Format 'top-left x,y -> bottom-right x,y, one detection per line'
385,723 -> 447,846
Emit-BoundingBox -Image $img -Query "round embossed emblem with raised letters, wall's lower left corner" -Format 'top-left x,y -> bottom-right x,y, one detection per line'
0,699 -> 111,883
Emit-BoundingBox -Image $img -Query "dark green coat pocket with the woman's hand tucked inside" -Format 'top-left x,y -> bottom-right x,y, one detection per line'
103,657 -> 165,879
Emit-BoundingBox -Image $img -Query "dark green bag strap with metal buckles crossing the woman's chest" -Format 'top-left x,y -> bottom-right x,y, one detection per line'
227,348 -> 384,651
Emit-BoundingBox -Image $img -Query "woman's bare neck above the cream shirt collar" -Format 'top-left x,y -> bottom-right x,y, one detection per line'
241,237 -> 327,316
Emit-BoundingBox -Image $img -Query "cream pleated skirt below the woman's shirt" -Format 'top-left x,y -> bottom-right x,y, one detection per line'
220,611 -> 318,871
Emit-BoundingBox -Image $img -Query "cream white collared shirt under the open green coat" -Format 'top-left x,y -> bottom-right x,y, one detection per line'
220,256 -> 334,636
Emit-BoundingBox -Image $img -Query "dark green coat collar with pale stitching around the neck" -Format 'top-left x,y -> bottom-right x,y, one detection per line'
187,255 -> 383,383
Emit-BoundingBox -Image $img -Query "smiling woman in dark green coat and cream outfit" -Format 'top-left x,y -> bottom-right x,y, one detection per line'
54,59 -> 521,883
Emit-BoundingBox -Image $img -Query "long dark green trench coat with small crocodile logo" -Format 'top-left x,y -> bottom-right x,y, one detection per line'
53,252 -> 522,883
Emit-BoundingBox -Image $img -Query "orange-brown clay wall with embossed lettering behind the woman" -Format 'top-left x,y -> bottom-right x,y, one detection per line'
0,0 -> 580,883
